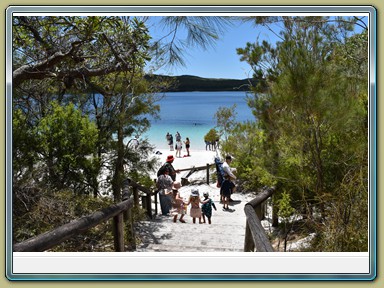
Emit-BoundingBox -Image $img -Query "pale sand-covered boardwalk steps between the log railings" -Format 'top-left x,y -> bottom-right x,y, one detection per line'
136,184 -> 252,252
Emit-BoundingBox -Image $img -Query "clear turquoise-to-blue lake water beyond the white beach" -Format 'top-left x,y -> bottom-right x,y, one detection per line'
141,91 -> 255,151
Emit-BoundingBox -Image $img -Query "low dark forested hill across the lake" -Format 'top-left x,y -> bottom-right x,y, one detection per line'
146,75 -> 254,92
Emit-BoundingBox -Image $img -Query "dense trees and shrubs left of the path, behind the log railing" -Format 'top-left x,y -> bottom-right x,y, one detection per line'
12,16 -> 234,251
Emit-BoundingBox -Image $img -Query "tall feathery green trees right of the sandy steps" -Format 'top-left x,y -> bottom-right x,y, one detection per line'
234,17 -> 368,251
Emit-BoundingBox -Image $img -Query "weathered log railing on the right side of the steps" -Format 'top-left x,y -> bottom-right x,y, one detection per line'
244,187 -> 275,252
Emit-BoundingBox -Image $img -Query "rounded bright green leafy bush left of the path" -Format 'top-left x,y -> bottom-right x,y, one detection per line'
35,102 -> 98,193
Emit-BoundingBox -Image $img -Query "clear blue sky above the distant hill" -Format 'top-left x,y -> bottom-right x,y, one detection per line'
145,18 -> 280,79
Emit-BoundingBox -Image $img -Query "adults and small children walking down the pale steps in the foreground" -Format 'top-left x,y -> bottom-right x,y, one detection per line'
156,155 -> 236,224
